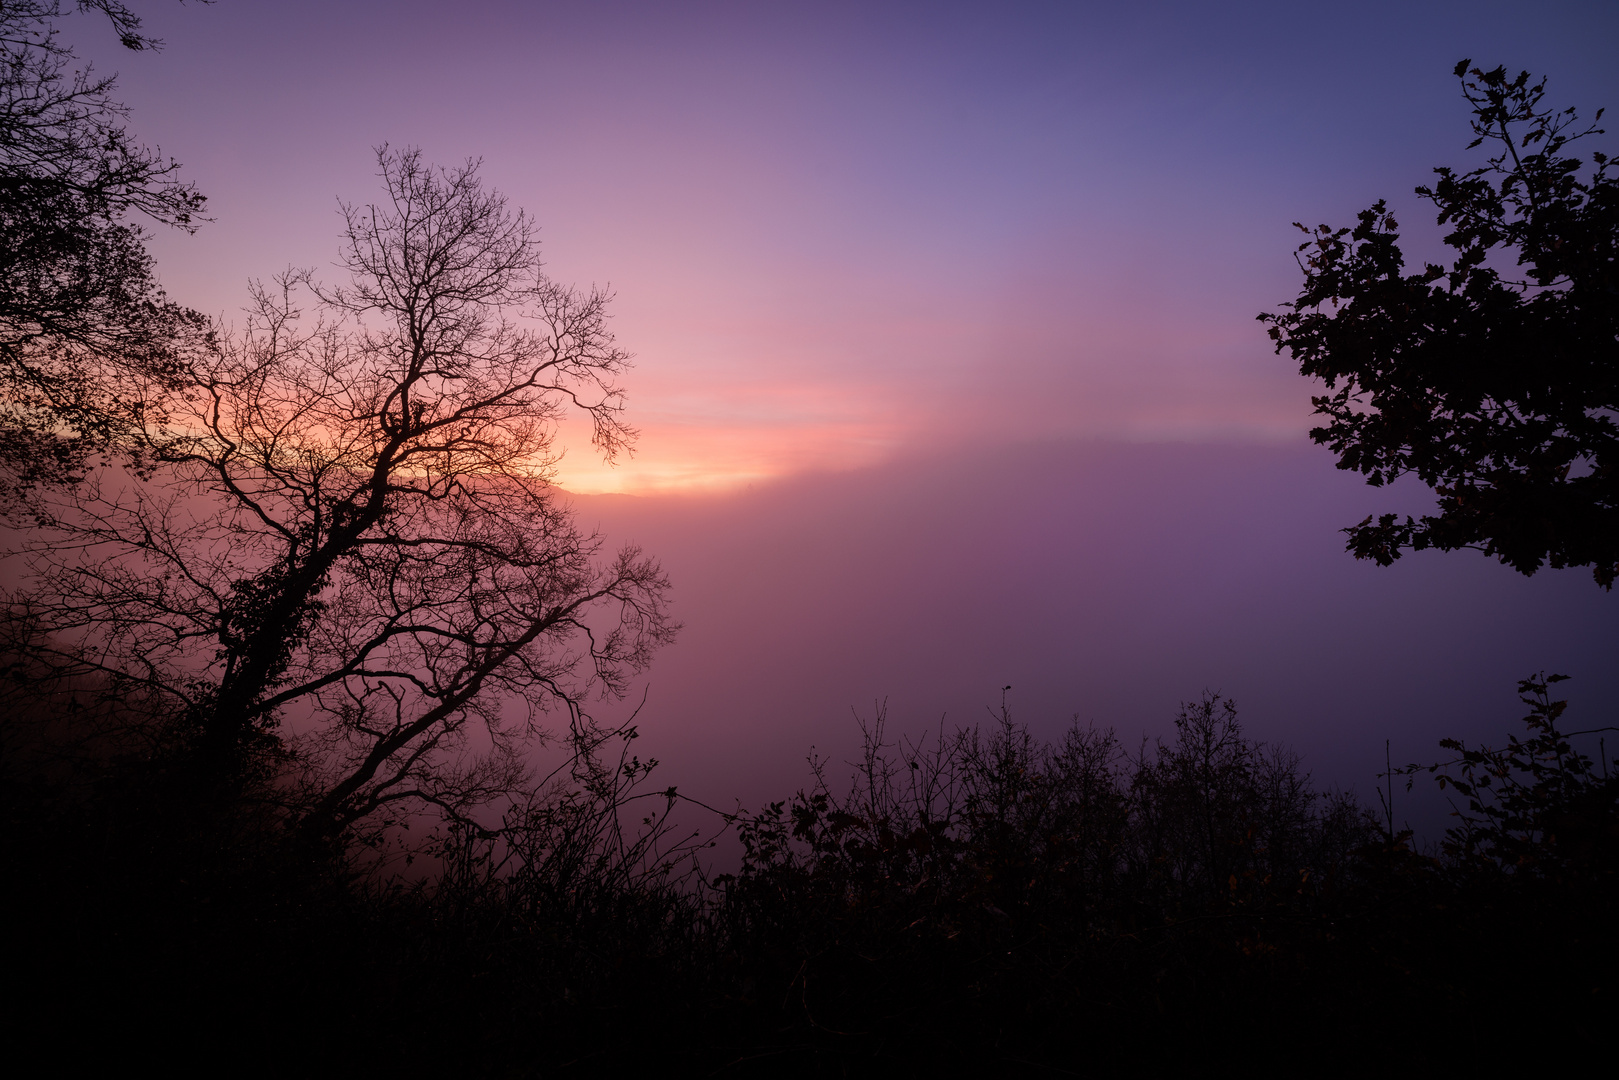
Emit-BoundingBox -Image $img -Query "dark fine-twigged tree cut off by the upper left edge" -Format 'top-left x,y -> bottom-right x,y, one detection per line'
0,0 -> 206,489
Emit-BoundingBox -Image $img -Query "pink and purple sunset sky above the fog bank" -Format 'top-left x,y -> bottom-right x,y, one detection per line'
81,0 -> 1619,491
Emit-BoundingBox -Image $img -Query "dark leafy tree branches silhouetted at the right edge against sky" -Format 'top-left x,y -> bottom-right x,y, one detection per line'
1260,60 -> 1619,589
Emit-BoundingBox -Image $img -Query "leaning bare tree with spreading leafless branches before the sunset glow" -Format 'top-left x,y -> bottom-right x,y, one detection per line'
11,147 -> 677,834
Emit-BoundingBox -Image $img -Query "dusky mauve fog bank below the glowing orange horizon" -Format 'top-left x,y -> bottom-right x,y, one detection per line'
575,442 -> 1619,834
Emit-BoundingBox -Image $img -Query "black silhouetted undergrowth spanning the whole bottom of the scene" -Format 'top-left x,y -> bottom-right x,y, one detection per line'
3,676 -> 1619,1075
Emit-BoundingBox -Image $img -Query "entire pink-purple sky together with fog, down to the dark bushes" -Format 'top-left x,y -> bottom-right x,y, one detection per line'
50,0 -> 1619,822
